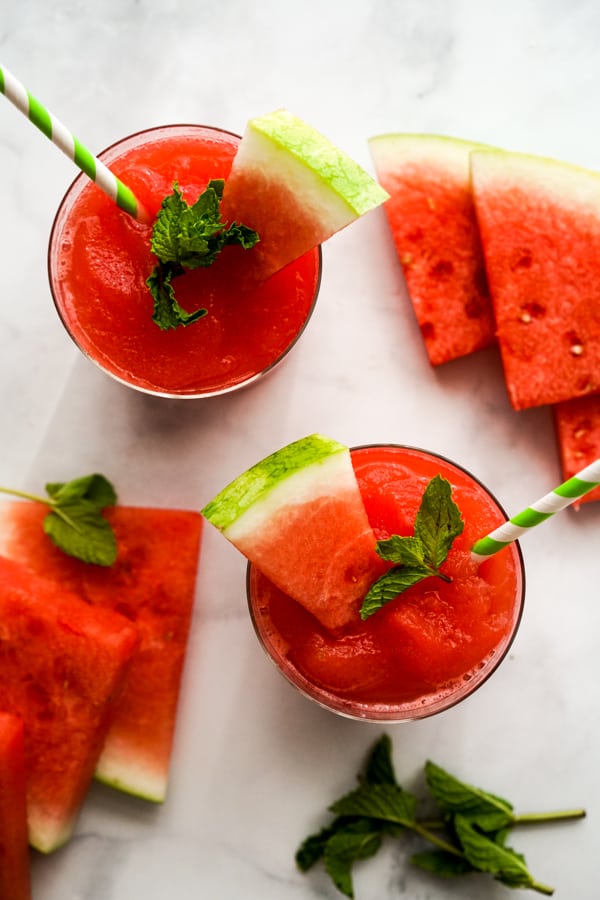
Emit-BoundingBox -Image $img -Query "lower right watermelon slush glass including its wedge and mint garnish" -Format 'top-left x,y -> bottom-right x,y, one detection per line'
203,435 -> 525,722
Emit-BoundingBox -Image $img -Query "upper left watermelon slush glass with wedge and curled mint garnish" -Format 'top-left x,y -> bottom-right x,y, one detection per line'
49,110 -> 387,397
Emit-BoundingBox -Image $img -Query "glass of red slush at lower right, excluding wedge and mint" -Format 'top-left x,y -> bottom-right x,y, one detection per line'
247,445 -> 525,722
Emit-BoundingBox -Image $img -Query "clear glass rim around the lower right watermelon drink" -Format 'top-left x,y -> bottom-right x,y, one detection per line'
245,442 -> 526,724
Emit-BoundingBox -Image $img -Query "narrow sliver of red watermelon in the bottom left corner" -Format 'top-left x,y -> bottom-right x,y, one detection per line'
0,712 -> 31,900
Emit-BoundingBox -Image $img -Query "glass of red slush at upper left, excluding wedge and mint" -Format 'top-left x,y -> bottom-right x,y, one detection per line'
48,125 -> 321,398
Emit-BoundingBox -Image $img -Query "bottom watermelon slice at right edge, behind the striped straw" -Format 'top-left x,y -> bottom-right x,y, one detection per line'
553,394 -> 600,507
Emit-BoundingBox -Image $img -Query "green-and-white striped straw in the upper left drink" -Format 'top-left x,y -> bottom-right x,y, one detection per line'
0,66 -> 151,224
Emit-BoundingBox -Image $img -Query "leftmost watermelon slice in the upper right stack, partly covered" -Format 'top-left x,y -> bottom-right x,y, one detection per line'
369,134 -> 495,366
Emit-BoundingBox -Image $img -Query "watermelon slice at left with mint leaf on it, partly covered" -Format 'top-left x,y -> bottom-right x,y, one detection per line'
0,501 -> 202,802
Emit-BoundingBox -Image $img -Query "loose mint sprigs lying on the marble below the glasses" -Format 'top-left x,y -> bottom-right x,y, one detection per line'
295,735 -> 585,897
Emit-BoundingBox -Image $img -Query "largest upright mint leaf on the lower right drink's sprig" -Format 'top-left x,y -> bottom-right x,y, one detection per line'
415,475 -> 465,569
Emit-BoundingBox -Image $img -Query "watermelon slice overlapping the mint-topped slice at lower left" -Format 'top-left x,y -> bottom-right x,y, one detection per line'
0,556 -> 138,853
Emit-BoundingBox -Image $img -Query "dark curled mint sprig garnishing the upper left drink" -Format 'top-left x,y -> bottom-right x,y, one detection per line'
146,179 -> 259,331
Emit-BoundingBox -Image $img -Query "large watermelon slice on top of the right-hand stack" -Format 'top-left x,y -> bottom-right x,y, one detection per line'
471,150 -> 600,409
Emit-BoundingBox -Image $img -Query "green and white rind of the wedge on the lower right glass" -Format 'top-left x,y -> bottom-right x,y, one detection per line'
201,434 -> 349,539
